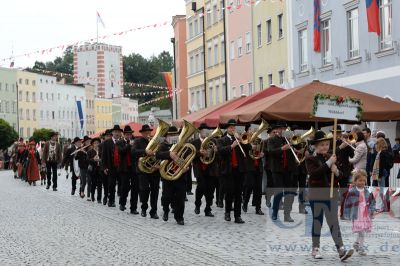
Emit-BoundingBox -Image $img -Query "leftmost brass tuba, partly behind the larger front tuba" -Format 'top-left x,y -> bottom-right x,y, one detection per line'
138,119 -> 169,174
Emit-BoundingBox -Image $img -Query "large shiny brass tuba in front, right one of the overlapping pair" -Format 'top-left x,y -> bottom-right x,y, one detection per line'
160,120 -> 198,181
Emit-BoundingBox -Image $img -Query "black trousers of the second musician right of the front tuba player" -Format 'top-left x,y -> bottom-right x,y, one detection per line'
224,169 -> 244,218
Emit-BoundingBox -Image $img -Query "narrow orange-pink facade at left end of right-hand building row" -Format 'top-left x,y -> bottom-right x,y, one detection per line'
172,15 -> 189,119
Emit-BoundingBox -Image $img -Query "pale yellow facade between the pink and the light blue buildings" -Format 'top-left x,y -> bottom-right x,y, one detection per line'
252,1 -> 290,91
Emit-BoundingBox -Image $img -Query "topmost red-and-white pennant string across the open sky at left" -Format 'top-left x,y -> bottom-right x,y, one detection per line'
0,21 -> 170,63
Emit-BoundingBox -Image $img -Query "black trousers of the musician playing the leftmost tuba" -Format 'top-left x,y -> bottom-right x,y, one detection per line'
138,173 -> 160,215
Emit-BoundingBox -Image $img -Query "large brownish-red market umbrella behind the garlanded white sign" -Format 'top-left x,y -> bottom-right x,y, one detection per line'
220,81 -> 400,123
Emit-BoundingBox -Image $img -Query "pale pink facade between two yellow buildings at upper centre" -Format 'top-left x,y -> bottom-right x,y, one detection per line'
226,0 -> 254,99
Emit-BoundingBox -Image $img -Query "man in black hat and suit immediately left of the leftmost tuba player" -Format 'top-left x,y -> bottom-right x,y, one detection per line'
117,125 -> 137,212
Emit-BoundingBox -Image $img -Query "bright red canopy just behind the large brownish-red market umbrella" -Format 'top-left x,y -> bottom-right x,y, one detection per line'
203,85 -> 284,127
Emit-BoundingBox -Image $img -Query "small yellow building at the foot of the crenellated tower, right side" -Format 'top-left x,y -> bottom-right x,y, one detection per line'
94,98 -> 113,133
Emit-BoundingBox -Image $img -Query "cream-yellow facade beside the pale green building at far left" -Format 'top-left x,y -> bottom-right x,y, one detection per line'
17,71 -> 39,139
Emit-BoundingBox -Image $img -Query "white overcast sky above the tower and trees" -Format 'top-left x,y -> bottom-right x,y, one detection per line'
0,0 -> 185,67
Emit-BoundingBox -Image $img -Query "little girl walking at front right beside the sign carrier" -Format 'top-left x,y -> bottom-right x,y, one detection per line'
344,169 -> 375,256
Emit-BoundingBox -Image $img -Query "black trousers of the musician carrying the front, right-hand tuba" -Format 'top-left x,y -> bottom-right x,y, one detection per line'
161,176 -> 187,221
